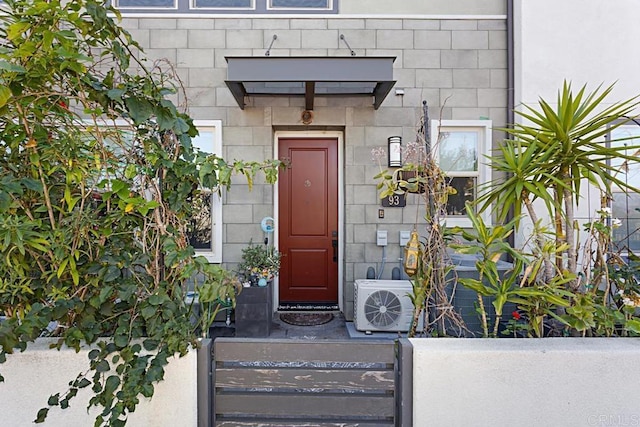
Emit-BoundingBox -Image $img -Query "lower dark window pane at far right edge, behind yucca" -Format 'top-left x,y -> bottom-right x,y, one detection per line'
611,193 -> 640,253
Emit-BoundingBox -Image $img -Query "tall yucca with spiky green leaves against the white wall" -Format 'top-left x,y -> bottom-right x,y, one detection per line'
480,82 -> 639,290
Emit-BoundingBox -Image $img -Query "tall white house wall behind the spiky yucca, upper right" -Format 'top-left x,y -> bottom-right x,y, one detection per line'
514,0 -> 640,251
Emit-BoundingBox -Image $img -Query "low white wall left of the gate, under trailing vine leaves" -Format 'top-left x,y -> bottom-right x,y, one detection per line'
0,339 -> 198,427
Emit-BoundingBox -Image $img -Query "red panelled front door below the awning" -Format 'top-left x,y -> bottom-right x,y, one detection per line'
278,138 -> 338,304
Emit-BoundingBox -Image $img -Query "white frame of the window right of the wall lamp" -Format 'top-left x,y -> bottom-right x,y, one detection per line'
430,120 -> 492,228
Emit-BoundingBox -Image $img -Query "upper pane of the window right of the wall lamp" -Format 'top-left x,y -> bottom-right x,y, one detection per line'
438,131 -> 478,172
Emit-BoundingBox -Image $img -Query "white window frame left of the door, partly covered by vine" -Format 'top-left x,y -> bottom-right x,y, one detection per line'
192,120 -> 222,264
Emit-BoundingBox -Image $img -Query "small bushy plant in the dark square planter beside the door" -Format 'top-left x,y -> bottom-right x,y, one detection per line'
238,242 -> 282,286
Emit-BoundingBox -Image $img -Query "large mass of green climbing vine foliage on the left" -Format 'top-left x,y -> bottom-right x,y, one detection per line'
0,0 -> 278,425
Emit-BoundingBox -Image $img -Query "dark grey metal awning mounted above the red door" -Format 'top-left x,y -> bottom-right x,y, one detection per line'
225,56 -> 396,110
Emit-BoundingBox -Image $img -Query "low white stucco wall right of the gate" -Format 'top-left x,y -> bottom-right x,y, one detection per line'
410,338 -> 640,427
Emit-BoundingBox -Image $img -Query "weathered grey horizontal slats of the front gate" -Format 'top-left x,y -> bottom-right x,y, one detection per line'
213,338 -> 397,427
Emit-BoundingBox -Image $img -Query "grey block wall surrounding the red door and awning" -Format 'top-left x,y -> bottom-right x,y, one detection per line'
117,15 -> 507,319
